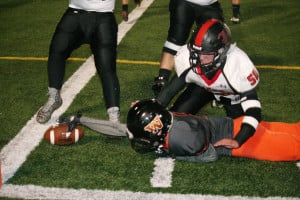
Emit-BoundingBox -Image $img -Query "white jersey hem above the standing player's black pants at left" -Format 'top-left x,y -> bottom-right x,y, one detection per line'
69,0 -> 116,12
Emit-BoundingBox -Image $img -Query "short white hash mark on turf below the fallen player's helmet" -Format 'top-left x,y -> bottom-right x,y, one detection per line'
150,158 -> 175,188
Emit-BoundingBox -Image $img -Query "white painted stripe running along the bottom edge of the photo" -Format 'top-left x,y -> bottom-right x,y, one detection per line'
0,184 -> 299,200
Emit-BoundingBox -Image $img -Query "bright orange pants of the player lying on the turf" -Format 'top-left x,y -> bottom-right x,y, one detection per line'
232,118 -> 300,161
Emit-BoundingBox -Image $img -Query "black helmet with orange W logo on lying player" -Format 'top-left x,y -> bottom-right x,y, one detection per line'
127,99 -> 172,153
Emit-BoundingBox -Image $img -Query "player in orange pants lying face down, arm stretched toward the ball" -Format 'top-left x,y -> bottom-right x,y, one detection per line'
61,99 -> 300,162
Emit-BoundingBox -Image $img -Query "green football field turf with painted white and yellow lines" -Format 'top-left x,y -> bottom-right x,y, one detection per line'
0,0 -> 300,199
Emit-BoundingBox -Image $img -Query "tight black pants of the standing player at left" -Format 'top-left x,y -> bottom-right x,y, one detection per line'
48,8 -> 120,107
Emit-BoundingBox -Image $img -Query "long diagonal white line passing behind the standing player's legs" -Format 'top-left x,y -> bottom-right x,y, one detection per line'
0,0 -> 154,183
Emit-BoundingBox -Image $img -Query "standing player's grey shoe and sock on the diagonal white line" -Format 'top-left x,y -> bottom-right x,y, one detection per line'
36,88 -> 62,124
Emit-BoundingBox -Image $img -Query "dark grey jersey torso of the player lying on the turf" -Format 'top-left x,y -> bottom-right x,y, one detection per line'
166,113 -> 233,157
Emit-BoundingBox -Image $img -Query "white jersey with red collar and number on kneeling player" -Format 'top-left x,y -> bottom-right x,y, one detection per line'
175,45 -> 259,104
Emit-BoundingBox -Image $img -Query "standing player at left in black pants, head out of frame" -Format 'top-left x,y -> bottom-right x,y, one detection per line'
36,0 -> 128,123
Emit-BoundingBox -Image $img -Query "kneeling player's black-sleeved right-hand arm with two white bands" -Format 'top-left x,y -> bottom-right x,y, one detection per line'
234,89 -> 262,146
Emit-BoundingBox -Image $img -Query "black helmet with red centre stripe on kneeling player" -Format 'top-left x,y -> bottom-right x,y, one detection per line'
188,19 -> 231,78
